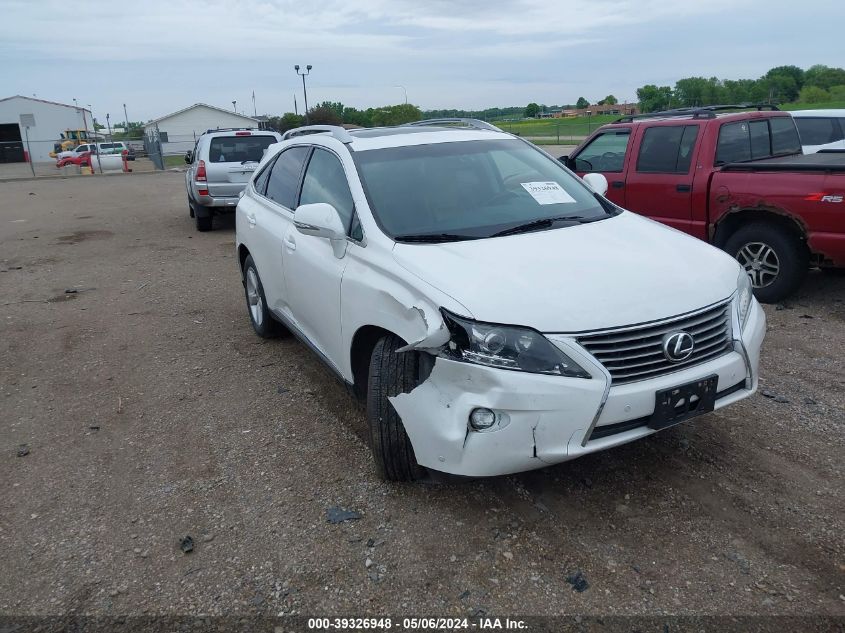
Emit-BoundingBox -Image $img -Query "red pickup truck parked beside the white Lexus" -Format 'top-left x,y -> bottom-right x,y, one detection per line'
561,106 -> 845,302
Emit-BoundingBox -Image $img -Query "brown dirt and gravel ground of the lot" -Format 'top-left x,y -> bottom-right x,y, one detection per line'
0,173 -> 845,616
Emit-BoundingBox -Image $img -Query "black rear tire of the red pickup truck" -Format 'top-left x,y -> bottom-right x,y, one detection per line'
725,222 -> 810,303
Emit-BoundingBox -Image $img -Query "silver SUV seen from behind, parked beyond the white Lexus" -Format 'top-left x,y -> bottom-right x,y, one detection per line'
185,128 -> 282,231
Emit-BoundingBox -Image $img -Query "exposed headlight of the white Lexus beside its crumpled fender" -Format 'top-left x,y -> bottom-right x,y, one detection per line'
441,310 -> 592,378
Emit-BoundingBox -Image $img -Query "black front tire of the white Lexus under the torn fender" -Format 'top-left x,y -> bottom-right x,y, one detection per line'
367,334 -> 425,481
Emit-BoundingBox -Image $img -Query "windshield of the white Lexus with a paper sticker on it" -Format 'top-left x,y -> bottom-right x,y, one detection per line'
353,139 -> 615,240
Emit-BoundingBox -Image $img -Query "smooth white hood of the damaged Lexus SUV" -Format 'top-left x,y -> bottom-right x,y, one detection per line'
393,212 -> 739,333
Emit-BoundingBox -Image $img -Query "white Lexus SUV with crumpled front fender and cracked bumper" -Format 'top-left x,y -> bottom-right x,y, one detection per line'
236,121 -> 765,480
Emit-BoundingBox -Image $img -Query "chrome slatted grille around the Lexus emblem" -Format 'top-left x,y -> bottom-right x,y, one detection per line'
577,301 -> 733,385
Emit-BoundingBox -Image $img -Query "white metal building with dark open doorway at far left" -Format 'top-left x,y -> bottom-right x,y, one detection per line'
0,95 -> 93,163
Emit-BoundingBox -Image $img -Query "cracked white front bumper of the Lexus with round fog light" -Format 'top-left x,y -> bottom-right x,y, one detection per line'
390,301 -> 766,477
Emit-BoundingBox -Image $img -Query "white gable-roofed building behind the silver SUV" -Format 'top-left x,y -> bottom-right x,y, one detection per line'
144,103 -> 258,155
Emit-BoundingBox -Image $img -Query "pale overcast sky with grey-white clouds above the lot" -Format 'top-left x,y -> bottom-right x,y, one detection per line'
0,0 -> 845,122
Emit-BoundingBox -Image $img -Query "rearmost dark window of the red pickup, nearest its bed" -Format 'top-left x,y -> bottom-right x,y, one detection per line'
716,116 -> 801,165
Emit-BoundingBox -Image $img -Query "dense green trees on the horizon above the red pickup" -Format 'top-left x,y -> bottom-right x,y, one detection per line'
637,64 -> 845,112
